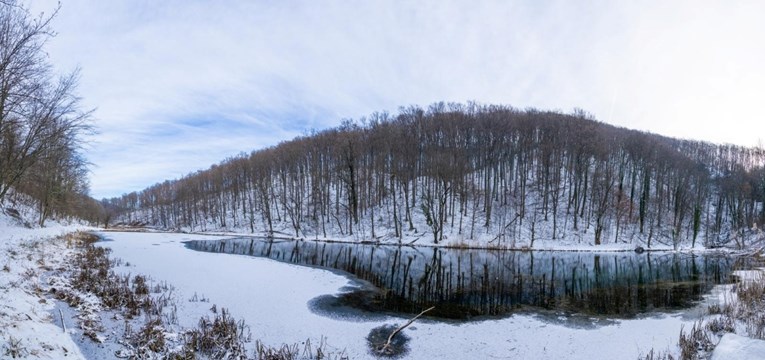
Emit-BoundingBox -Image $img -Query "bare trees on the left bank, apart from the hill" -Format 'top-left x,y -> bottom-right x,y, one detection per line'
0,0 -> 97,226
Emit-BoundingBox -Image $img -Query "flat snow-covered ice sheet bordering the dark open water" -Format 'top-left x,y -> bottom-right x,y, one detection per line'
94,232 -> 716,359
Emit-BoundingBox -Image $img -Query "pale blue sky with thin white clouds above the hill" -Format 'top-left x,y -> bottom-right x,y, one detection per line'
28,0 -> 765,199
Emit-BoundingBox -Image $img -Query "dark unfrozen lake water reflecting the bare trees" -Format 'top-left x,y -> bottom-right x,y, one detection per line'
186,238 -> 747,319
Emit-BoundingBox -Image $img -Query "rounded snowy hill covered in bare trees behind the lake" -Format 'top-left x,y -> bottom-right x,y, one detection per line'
104,103 -> 765,247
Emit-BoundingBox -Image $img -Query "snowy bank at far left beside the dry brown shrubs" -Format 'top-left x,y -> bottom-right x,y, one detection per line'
0,212 -> 90,359
